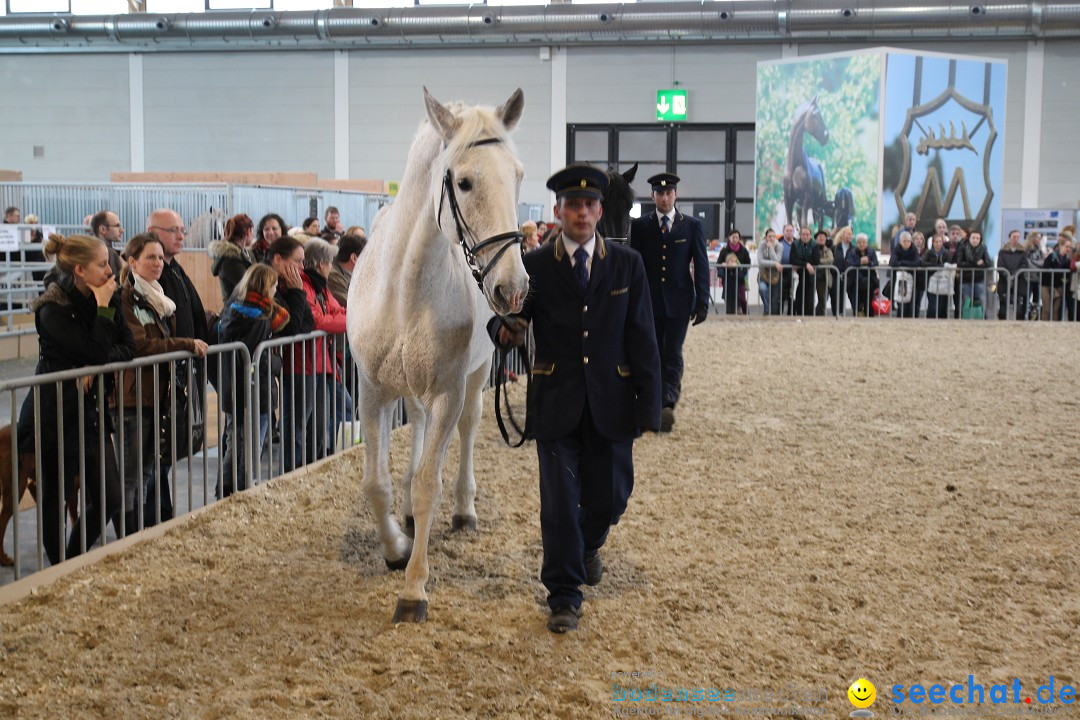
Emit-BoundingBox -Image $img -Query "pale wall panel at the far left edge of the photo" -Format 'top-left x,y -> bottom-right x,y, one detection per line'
0,54 -> 131,181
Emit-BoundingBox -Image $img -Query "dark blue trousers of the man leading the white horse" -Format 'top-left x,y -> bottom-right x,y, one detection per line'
537,404 -> 634,610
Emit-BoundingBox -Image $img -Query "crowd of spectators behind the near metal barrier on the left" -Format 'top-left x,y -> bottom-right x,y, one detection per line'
5,202 -> 366,563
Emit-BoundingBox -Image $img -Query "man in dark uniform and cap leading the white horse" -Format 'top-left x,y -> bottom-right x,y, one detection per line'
491,163 -> 660,633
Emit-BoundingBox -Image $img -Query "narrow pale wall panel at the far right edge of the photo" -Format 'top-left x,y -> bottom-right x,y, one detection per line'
1039,40 -> 1080,207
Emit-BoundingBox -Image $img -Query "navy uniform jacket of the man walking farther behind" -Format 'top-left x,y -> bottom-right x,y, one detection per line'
630,208 -> 708,318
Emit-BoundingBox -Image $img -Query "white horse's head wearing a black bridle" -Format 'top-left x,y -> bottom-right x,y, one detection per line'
423,87 -> 529,315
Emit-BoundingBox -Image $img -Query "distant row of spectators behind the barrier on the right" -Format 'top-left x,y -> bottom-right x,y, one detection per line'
716,214 -> 1080,321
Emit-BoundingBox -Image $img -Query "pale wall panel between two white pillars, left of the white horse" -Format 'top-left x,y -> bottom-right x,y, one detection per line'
143,51 -> 334,177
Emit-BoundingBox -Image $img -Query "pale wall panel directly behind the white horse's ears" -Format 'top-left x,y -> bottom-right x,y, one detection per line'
349,47 -> 551,204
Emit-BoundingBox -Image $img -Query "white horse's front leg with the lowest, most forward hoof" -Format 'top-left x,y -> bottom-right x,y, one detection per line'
393,379 -> 464,623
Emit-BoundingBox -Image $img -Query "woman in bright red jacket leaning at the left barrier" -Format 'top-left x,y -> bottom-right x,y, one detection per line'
285,237 -> 345,466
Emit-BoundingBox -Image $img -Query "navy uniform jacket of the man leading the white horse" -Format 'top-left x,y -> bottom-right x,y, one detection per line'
521,237 -> 661,440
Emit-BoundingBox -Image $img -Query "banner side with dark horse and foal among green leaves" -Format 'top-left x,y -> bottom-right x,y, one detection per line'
754,51 -> 885,241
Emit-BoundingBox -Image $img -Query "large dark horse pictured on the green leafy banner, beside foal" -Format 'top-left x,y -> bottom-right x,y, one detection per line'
784,95 -> 828,228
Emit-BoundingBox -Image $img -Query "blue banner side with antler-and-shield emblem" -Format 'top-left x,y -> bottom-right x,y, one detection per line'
881,50 -> 1008,257
